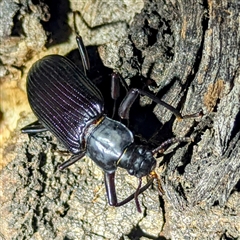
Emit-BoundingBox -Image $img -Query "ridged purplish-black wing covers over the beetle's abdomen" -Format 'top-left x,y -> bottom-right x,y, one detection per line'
27,55 -> 104,154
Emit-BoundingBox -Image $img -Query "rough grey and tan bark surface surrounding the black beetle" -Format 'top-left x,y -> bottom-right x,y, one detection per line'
0,0 -> 240,239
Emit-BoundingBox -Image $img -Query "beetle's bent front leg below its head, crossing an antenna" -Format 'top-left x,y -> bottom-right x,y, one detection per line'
104,172 -> 154,212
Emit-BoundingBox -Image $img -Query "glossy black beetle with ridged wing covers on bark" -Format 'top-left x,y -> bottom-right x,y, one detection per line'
22,35 -> 201,212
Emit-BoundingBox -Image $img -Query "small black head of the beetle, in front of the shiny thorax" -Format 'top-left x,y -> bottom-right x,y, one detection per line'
118,145 -> 156,178
